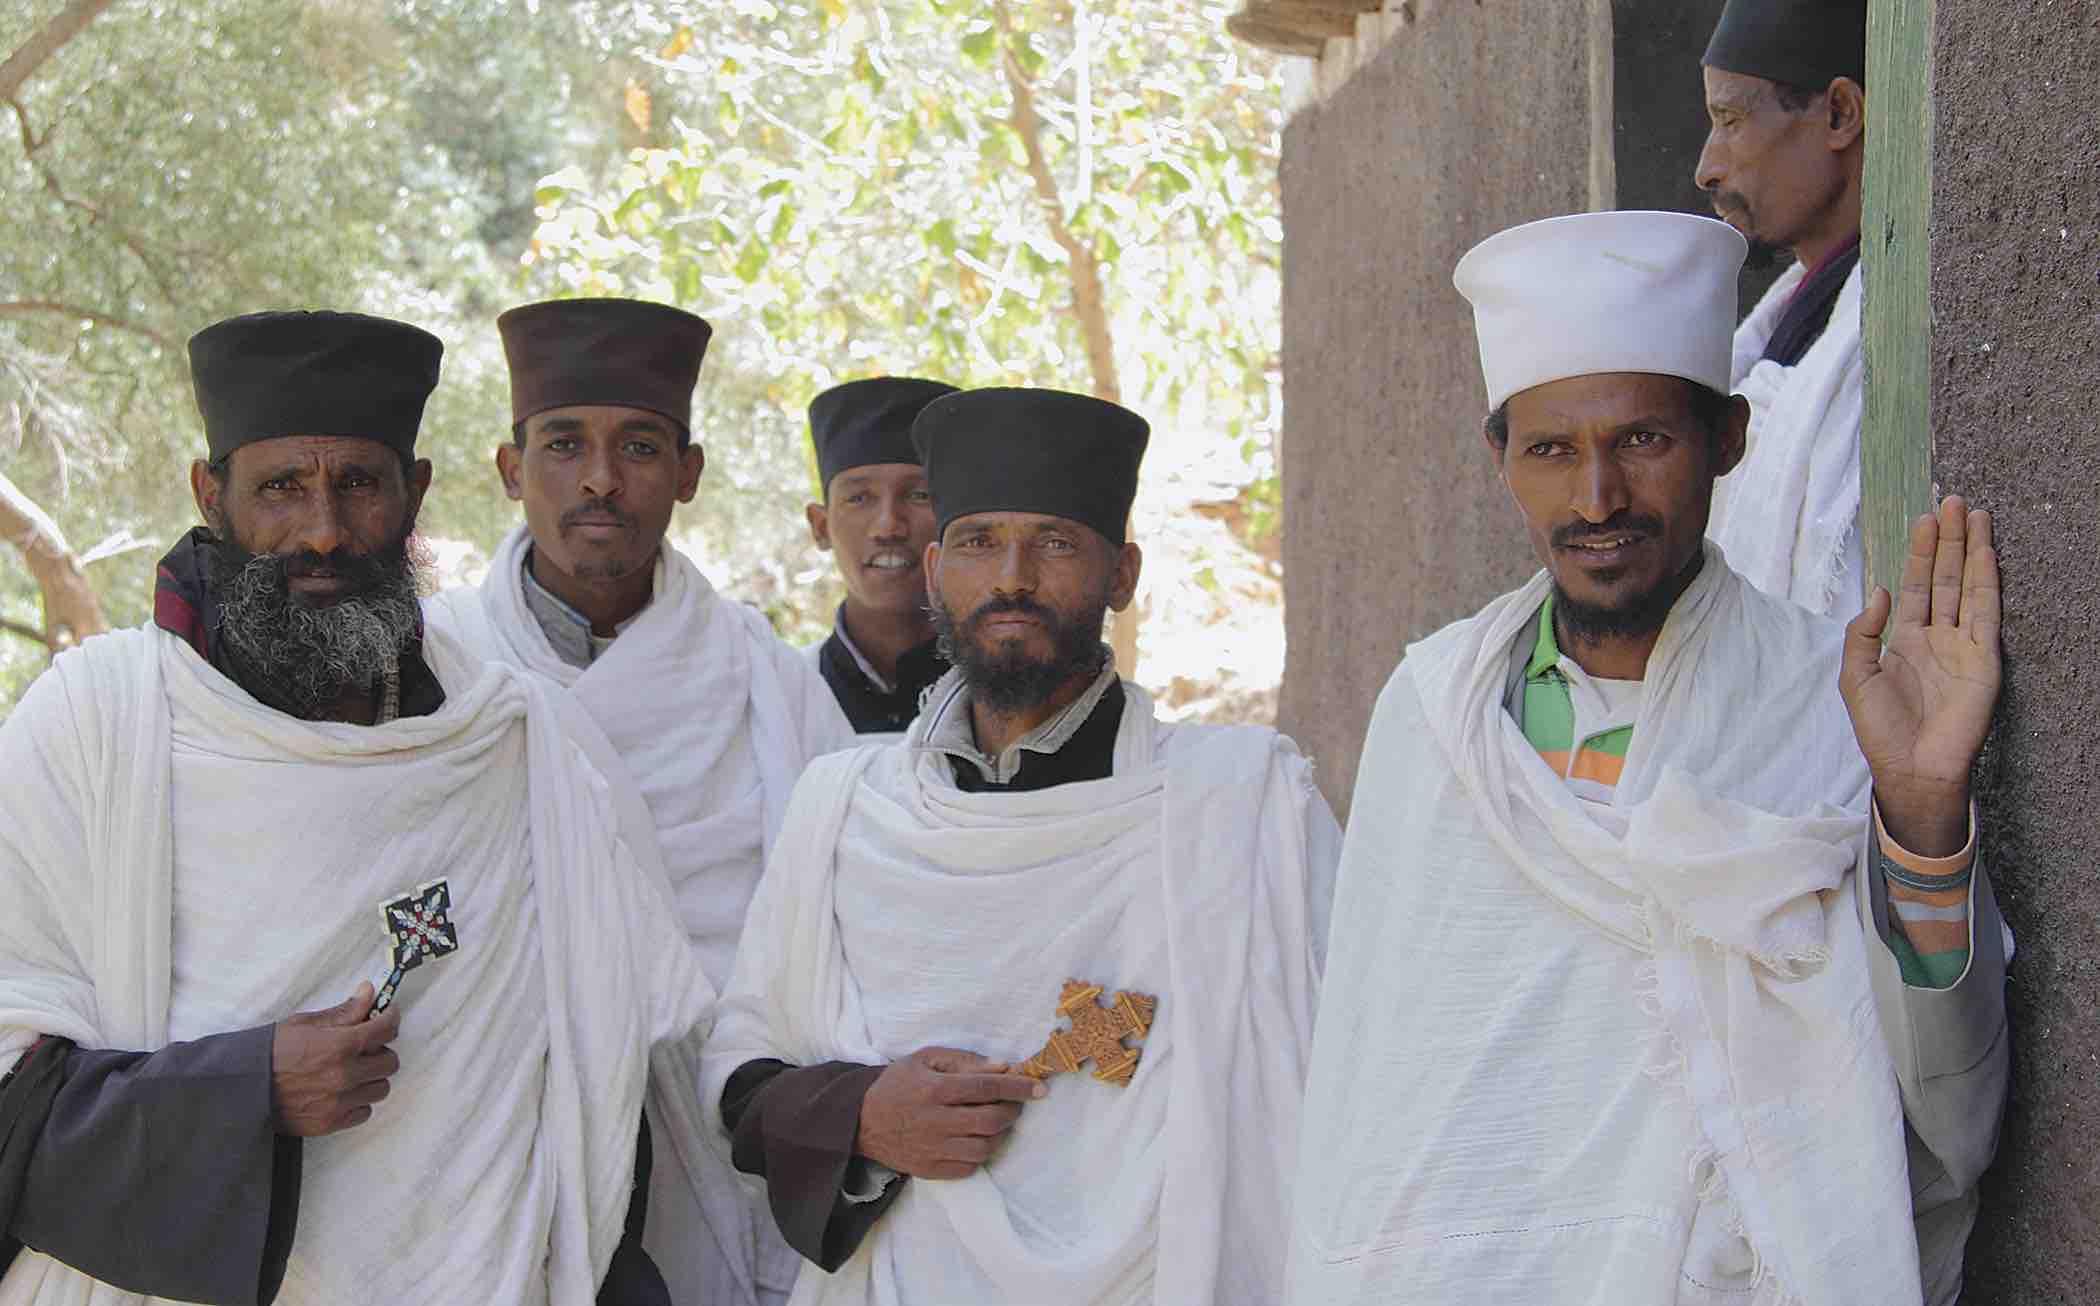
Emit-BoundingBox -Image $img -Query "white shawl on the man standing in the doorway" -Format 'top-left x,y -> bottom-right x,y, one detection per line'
1707,265 -> 1867,617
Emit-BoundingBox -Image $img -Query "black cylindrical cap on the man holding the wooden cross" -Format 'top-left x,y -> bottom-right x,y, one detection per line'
911,388 -> 1151,544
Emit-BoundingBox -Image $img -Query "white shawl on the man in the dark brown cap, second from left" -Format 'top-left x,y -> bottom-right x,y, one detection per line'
426,527 -> 853,1306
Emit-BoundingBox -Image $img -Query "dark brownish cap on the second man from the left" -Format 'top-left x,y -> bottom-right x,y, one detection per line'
496,300 -> 714,433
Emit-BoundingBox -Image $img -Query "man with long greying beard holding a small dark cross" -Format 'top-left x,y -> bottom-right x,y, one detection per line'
0,313 -> 714,1306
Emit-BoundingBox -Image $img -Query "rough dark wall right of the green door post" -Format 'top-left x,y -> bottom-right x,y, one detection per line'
1923,0 -> 2100,1306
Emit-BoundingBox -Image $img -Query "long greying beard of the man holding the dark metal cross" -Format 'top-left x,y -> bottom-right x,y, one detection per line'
208,527 -> 422,720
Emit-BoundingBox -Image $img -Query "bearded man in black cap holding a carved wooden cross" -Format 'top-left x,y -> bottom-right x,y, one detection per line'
701,388 -> 1340,1306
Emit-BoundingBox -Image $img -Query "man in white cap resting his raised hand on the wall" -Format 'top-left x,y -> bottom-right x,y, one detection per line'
1287,212 -> 2008,1306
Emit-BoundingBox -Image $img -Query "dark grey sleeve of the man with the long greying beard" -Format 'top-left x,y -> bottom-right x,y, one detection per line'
6,1025 -> 302,1306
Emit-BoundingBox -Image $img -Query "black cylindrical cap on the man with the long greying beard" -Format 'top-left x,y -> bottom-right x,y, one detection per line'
189,313 -> 445,462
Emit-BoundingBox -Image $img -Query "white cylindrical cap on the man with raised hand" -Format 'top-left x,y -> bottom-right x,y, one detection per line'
1451,212 -> 1749,409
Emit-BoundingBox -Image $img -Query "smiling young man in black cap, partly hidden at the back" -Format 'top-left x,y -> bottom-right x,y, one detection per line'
806,376 -> 956,739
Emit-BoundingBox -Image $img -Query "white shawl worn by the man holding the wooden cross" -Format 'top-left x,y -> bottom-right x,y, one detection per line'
701,682 -> 1331,1306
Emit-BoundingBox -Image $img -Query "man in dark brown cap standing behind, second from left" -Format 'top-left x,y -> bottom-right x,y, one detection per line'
428,298 -> 853,1306
